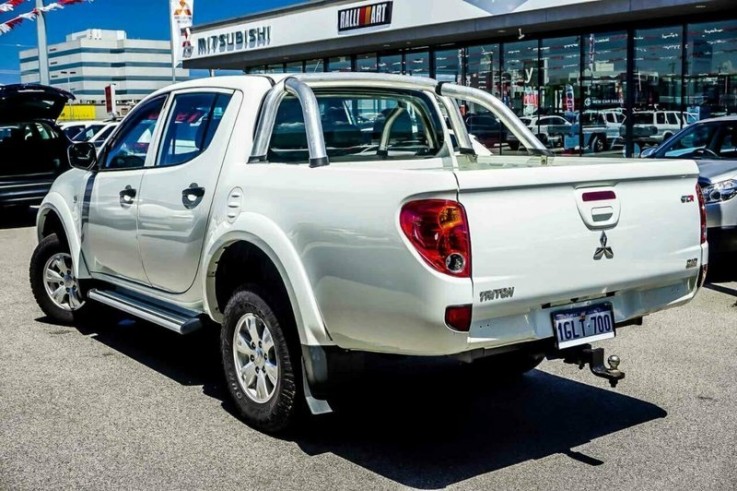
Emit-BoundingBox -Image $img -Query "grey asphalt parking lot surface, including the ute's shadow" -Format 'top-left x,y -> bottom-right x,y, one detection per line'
0,210 -> 737,490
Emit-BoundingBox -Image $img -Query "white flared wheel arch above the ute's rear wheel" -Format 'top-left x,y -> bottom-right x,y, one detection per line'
202,217 -> 334,345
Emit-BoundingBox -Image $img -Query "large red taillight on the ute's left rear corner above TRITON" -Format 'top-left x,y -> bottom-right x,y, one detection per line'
399,199 -> 471,278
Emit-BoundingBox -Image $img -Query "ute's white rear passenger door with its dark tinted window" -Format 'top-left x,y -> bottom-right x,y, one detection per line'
138,89 -> 233,293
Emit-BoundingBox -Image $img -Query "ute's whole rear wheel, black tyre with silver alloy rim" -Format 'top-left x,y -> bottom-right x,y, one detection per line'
220,287 -> 301,433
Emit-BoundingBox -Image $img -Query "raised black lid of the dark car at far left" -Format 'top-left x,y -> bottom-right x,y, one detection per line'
0,84 -> 74,123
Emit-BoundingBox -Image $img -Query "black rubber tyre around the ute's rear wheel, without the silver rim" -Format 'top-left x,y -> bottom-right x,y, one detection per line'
220,284 -> 304,433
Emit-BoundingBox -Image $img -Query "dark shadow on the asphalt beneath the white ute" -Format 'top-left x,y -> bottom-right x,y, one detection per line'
39,314 -> 667,489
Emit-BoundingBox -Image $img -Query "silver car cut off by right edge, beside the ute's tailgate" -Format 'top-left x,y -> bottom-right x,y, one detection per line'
642,116 -> 737,262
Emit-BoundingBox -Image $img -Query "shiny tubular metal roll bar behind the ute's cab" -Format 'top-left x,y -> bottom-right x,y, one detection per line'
248,73 -> 553,167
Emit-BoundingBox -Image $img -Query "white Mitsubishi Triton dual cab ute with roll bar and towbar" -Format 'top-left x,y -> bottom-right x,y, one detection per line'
30,74 -> 707,432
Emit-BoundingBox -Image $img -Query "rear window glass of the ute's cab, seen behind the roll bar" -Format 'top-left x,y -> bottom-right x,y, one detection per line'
268,91 -> 443,163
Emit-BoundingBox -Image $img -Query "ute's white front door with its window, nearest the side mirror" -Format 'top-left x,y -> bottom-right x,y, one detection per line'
82,96 -> 166,284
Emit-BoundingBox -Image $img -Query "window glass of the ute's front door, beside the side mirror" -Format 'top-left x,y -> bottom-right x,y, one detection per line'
103,96 -> 166,169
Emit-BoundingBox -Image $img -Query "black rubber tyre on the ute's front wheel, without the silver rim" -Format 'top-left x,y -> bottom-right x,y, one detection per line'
28,234 -> 90,324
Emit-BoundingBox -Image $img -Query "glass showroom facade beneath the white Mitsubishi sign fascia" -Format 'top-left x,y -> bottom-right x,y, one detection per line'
246,19 -> 737,156
